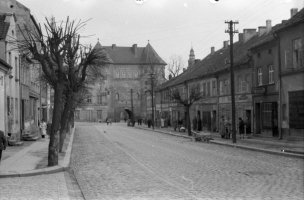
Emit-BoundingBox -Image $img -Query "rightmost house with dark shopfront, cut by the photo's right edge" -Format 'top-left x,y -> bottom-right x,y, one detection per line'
275,9 -> 304,139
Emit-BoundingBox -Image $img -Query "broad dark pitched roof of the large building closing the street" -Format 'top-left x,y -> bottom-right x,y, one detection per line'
94,42 -> 166,65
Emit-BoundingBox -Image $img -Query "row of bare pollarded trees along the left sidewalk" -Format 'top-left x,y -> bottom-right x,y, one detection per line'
17,17 -> 109,166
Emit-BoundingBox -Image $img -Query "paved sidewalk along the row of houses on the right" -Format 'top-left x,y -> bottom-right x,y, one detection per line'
135,125 -> 304,158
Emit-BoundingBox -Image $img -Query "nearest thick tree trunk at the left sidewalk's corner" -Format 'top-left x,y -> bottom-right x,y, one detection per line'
48,83 -> 64,166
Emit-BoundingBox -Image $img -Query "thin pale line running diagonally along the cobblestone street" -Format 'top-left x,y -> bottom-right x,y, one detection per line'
95,127 -> 198,199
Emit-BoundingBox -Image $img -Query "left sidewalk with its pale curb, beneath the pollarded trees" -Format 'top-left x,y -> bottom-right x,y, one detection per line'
0,128 -> 75,178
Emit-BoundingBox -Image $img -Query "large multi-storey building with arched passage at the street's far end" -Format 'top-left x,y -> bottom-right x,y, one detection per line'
75,42 -> 166,121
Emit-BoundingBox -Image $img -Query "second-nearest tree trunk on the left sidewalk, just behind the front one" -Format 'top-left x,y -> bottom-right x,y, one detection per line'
59,94 -> 74,152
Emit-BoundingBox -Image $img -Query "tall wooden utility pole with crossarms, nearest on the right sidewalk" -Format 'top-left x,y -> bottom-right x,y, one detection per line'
225,20 -> 239,143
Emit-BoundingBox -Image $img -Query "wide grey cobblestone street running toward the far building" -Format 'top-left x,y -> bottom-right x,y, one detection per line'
71,124 -> 304,199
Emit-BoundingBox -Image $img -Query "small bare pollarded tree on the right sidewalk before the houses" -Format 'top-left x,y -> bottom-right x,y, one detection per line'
171,85 -> 203,136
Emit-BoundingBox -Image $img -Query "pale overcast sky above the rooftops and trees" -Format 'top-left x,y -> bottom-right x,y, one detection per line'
18,0 -> 304,67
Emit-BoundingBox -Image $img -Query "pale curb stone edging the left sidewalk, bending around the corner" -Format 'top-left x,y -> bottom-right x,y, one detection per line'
0,126 -> 75,178
